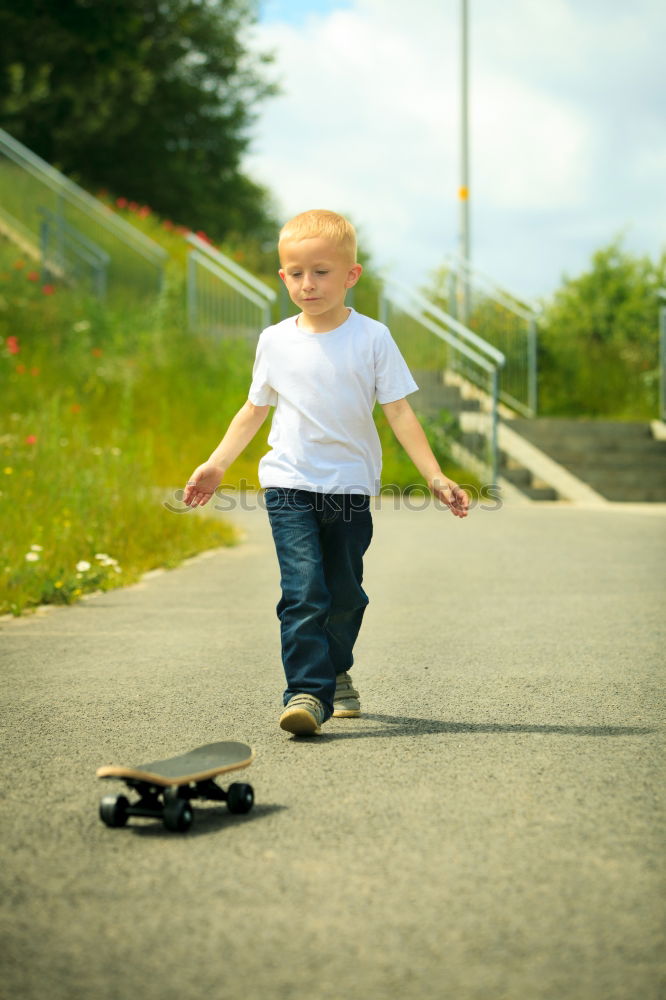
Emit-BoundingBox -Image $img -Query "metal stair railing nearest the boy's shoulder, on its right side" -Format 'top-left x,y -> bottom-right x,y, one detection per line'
379,281 -> 505,485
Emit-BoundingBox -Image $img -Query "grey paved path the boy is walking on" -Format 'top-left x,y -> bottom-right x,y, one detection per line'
0,506 -> 666,1000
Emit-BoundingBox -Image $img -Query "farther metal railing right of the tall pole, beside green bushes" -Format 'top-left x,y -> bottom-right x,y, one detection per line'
446,256 -> 539,417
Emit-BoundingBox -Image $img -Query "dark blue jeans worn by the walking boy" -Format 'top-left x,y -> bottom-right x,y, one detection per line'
265,487 -> 372,718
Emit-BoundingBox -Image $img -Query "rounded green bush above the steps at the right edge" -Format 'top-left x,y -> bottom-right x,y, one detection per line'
539,240 -> 666,420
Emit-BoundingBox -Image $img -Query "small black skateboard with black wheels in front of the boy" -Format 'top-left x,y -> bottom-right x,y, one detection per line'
97,742 -> 254,833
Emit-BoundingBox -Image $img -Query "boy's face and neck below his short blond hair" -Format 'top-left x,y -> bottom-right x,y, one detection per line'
279,236 -> 362,333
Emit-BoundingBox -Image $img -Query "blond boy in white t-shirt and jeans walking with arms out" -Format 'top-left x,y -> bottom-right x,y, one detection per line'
184,210 -> 469,736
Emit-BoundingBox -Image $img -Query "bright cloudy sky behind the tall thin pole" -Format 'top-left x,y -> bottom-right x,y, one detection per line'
245,0 -> 666,299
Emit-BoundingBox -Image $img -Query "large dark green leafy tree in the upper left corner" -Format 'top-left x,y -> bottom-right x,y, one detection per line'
0,0 -> 275,239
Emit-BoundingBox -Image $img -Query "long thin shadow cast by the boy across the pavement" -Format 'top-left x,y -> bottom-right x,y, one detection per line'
318,713 -> 658,740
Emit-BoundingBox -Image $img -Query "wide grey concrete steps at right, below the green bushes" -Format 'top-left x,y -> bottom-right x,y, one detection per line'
502,417 -> 666,503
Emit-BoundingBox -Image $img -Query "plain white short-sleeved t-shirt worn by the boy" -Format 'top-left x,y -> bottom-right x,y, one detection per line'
248,309 -> 418,496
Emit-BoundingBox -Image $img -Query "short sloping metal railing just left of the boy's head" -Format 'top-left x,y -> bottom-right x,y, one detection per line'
187,233 -> 277,341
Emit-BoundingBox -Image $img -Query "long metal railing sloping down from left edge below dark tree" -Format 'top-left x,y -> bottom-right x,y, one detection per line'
0,129 -> 168,299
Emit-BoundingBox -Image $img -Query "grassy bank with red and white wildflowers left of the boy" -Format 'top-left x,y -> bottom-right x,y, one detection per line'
0,243 -> 252,614
